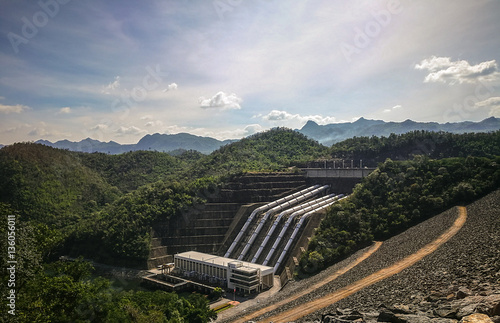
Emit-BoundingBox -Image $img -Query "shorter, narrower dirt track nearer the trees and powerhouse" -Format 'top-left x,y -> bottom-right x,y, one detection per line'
232,241 -> 382,323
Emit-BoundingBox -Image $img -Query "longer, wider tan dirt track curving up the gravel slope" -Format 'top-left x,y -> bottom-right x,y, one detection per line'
260,207 -> 467,323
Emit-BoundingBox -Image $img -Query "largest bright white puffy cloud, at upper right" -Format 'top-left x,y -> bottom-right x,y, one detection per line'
415,56 -> 500,84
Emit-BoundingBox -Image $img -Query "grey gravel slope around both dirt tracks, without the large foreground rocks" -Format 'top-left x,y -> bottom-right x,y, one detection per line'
221,191 -> 500,322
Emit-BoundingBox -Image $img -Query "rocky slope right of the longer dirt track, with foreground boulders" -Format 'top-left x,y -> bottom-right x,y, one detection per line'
316,191 -> 500,323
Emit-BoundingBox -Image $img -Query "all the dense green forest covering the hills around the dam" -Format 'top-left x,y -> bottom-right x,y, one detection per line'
0,128 -> 500,322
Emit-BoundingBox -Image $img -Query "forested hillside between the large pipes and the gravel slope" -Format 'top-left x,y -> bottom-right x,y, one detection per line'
300,156 -> 500,274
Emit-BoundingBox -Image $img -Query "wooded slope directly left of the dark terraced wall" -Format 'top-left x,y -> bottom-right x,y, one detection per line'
64,180 -> 212,267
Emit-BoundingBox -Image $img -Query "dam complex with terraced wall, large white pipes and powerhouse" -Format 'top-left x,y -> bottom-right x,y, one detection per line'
148,168 -> 373,294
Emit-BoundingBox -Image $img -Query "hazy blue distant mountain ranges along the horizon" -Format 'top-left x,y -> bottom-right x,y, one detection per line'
12,117 -> 500,154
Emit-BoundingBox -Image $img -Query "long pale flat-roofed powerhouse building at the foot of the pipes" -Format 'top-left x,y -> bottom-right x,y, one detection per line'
174,251 -> 274,294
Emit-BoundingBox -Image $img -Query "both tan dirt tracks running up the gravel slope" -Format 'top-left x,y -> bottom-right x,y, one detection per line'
235,207 -> 467,323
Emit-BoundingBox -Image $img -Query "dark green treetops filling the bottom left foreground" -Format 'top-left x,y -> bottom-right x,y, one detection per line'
0,215 -> 217,323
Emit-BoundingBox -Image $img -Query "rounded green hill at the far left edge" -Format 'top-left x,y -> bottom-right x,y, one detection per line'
0,143 -> 121,228
